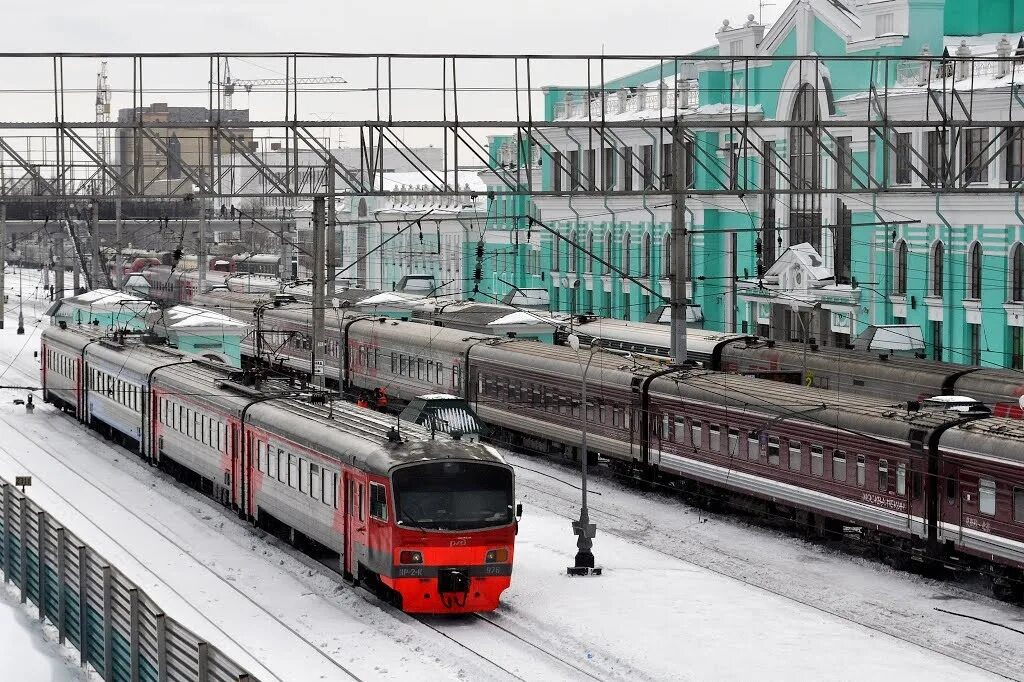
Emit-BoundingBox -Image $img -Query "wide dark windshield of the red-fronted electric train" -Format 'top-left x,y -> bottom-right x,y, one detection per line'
393,461 -> 514,530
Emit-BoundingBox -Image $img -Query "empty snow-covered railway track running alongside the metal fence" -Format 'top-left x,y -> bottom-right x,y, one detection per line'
0,409 -> 362,682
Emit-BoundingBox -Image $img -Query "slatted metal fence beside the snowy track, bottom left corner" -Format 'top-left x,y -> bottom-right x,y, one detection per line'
0,478 -> 256,682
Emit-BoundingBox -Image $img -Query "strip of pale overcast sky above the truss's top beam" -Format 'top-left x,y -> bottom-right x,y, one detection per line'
6,0 -> 784,53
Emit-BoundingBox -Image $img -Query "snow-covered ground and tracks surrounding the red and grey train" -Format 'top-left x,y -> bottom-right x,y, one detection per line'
0,266 -> 1024,680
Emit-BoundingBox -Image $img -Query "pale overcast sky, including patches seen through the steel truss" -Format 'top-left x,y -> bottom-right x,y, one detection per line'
0,0 -> 785,151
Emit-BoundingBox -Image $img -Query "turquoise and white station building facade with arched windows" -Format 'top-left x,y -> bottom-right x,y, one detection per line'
475,0 -> 1024,369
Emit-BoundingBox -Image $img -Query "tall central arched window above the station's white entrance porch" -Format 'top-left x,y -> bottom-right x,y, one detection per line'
790,83 -> 821,253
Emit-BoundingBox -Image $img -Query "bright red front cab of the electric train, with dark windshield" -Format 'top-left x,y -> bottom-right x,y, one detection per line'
356,460 -> 520,613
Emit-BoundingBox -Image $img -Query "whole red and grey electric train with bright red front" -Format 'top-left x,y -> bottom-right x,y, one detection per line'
42,327 -> 518,613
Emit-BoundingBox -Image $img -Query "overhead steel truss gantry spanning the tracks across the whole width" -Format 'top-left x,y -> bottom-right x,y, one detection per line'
0,52 -> 1024,204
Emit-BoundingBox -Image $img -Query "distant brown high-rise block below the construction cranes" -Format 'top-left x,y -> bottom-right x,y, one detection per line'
117,102 -> 253,196
